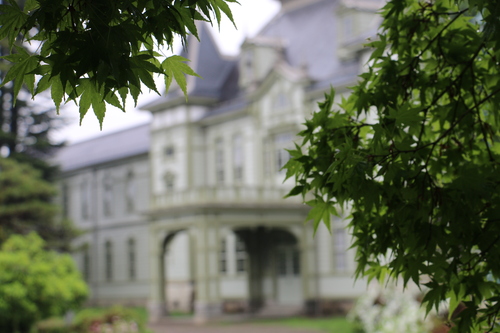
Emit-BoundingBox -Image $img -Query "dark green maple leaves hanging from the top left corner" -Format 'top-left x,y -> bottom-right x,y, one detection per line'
0,0 -> 236,126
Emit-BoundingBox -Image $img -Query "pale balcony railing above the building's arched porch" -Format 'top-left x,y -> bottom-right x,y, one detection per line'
153,186 -> 302,208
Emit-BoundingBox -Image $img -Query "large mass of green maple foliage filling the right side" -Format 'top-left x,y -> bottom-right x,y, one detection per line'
286,0 -> 500,332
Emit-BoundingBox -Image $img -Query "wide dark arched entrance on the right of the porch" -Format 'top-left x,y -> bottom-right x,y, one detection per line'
234,226 -> 304,312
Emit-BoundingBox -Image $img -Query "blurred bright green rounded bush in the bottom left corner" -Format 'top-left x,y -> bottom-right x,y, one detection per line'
0,233 -> 88,333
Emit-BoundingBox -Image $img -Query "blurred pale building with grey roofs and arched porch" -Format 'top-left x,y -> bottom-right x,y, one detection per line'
57,0 -> 380,319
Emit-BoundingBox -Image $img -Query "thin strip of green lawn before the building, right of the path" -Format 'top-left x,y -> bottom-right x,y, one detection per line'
256,317 -> 358,333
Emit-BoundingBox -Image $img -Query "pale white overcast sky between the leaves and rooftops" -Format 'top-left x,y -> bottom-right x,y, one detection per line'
53,0 -> 280,144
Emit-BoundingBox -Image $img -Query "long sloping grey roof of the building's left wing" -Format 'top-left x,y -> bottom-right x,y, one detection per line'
53,124 -> 150,171
